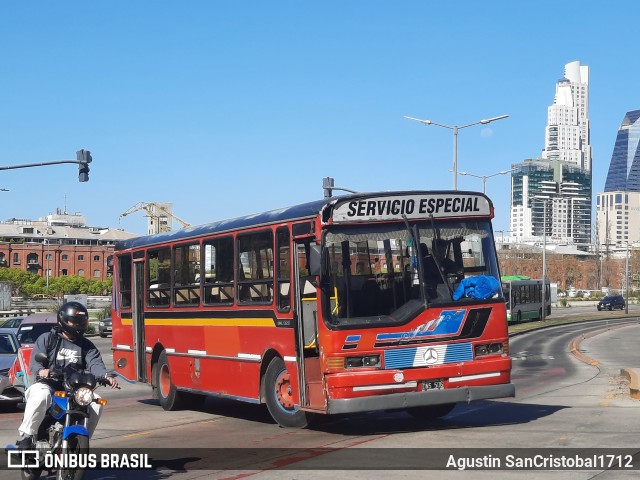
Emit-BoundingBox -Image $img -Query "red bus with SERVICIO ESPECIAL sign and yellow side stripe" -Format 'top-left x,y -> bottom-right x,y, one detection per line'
112,191 -> 515,427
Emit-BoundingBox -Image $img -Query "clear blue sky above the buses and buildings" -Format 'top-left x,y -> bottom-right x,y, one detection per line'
0,0 -> 640,234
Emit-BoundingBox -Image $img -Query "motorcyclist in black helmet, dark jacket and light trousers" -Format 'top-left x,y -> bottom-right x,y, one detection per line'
16,302 -> 118,449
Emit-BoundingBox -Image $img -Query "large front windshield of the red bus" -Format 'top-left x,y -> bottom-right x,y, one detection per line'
323,220 -> 499,325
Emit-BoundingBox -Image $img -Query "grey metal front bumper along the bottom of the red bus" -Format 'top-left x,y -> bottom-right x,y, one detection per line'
327,383 -> 516,414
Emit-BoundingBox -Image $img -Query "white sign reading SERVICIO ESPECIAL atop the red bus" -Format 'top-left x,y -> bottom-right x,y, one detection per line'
332,192 -> 491,223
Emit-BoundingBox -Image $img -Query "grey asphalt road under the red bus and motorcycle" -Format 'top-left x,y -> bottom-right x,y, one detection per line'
0,310 -> 640,480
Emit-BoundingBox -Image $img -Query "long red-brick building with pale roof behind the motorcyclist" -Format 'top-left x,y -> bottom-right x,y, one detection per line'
0,211 -> 137,280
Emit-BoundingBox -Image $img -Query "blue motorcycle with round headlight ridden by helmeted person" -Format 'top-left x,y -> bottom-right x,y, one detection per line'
10,353 -> 119,480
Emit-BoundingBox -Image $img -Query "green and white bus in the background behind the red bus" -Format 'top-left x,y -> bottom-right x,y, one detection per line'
502,275 -> 551,323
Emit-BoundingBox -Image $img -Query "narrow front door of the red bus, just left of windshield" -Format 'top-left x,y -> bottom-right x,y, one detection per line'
294,239 -> 326,410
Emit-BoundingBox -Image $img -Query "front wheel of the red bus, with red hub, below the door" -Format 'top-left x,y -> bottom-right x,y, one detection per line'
264,357 -> 312,428
